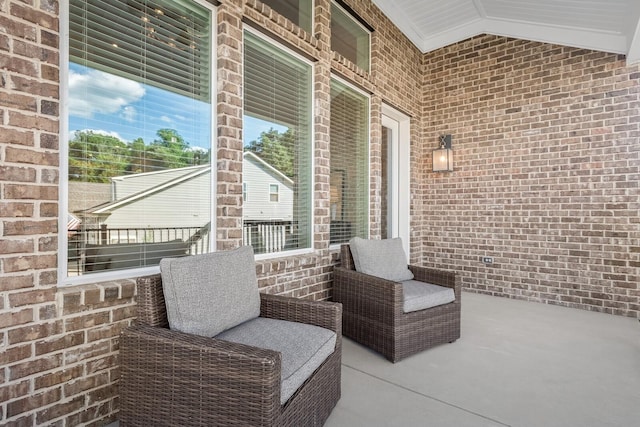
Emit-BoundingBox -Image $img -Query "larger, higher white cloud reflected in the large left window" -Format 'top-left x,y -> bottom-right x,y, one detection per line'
69,70 -> 145,120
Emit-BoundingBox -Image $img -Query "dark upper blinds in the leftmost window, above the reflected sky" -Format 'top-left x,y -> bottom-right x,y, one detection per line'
69,0 -> 211,101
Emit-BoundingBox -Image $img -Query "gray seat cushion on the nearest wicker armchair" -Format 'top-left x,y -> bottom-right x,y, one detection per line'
215,317 -> 336,404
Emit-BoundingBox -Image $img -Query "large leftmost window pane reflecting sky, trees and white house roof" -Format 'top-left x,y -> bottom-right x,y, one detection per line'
61,0 -> 214,281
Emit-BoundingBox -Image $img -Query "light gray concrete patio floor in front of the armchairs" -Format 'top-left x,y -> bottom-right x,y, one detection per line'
110,292 -> 640,427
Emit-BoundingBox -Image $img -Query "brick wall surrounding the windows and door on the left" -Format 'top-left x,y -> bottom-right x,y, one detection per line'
0,0 -> 422,426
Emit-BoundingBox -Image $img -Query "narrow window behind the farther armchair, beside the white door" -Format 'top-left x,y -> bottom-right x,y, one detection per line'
330,78 -> 369,243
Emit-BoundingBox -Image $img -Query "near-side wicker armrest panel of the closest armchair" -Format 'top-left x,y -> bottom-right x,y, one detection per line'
120,325 -> 281,425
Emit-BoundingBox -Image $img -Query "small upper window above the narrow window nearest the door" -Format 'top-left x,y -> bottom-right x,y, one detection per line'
331,2 -> 371,71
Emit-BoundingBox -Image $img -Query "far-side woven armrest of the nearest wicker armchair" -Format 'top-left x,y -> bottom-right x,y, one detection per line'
260,294 -> 342,335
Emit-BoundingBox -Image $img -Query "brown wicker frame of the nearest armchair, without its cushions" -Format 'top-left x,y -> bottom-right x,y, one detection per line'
120,274 -> 342,427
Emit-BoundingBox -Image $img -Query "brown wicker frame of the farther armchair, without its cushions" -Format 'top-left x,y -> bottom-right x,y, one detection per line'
333,244 -> 461,363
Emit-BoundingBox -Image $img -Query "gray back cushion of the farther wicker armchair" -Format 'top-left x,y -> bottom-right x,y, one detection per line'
349,237 -> 413,282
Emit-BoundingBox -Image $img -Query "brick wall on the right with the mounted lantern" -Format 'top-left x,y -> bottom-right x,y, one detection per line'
414,36 -> 640,317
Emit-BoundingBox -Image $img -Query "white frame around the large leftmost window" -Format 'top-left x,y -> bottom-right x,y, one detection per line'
58,0 -> 217,286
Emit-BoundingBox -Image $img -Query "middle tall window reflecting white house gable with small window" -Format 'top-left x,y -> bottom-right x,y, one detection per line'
242,30 -> 313,254
